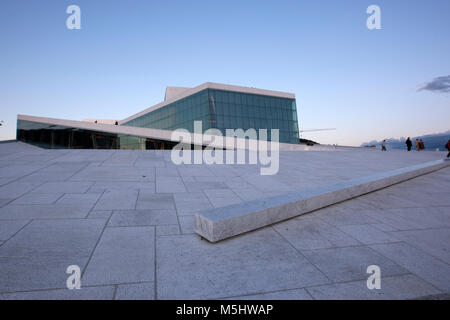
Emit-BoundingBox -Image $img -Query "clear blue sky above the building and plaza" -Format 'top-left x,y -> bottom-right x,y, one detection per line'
0,0 -> 450,145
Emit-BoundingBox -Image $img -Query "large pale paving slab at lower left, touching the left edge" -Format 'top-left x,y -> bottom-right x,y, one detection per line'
0,219 -> 105,293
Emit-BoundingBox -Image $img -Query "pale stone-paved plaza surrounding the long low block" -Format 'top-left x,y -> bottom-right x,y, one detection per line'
0,143 -> 450,299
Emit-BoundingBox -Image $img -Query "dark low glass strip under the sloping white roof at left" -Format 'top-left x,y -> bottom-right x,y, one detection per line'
17,120 -> 176,150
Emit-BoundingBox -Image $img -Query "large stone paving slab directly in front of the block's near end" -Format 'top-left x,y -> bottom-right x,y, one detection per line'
156,229 -> 328,299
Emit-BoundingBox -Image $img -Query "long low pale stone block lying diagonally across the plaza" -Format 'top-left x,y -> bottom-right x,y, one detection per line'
194,160 -> 450,242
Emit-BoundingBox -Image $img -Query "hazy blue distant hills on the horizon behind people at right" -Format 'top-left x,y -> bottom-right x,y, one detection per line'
361,130 -> 450,151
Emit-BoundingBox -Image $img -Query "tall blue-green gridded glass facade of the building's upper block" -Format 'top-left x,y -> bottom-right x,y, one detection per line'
123,89 -> 300,144
